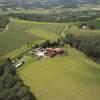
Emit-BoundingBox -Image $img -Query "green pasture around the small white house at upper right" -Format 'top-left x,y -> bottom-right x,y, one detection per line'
64,18 -> 100,36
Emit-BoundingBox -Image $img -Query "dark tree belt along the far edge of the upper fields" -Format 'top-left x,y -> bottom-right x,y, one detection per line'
9,12 -> 97,23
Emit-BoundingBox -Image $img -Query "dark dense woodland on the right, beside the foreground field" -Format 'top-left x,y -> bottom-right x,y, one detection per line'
64,34 -> 100,63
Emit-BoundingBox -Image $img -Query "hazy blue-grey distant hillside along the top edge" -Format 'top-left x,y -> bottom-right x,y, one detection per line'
0,0 -> 100,8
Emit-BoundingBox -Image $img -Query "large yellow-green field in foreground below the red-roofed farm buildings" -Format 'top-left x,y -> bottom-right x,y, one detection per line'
18,48 -> 100,100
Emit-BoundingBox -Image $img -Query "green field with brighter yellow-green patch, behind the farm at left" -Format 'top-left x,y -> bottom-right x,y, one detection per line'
0,20 -> 65,56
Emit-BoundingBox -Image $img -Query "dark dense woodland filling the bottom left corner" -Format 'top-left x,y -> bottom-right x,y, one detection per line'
0,58 -> 36,100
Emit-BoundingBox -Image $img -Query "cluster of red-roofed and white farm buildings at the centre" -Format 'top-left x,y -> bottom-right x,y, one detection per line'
33,48 -> 66,58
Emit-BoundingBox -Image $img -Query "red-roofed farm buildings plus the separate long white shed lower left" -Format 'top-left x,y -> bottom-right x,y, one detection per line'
14,47 -> 68,68
